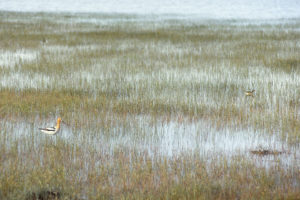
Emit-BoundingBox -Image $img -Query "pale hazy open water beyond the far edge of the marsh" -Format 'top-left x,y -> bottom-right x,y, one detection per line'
0,0 -> 300,19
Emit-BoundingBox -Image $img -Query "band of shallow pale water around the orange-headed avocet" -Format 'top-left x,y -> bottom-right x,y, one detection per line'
0,116 -> 300,170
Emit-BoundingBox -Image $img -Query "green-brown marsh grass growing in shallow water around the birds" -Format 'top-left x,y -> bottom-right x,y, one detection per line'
0,12 -> 300,199
